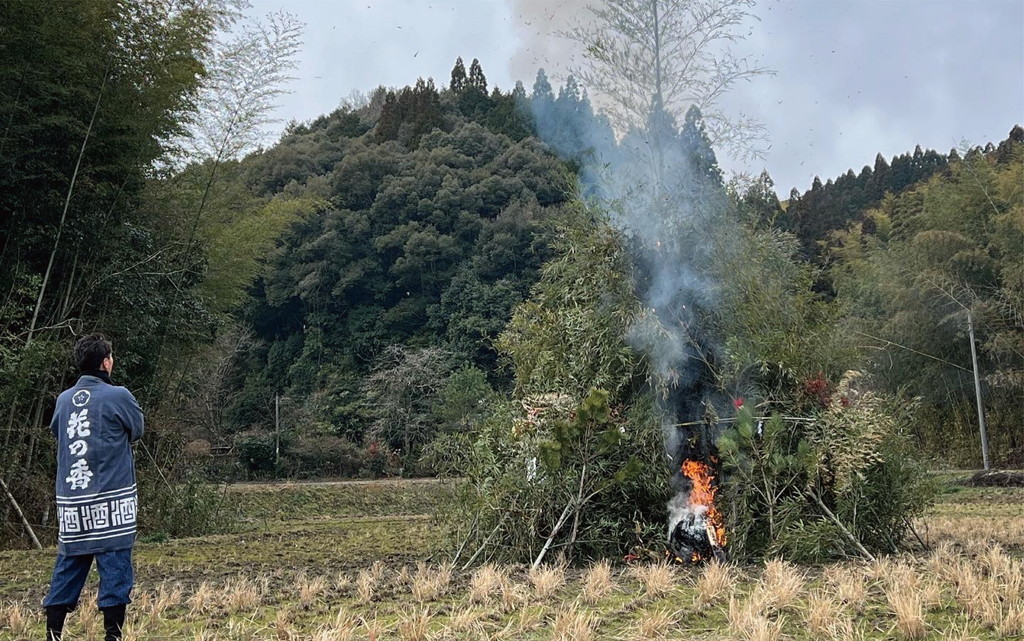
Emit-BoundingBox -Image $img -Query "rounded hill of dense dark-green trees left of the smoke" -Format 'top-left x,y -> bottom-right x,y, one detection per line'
226,59 -> 606,462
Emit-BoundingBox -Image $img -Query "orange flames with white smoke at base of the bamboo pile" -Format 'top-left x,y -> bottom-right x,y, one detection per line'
669,460 -> 726,563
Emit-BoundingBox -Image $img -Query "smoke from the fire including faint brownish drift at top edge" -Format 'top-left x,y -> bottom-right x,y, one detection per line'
513,0 -> 745,541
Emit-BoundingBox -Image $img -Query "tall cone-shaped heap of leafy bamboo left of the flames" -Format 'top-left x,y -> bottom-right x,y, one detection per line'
433,210 -> 670,561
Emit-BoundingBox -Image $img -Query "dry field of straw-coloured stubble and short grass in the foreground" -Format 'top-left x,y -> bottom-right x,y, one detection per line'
0,471 -> 1024,641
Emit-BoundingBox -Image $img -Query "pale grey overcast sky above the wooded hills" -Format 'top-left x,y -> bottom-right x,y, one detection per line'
251,0 -> 1024,198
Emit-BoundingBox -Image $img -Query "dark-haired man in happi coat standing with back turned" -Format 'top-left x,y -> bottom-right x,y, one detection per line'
43,334 -> 142,641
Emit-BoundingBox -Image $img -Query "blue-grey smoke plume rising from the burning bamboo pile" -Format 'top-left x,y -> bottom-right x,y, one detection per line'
516,0 -> 731,552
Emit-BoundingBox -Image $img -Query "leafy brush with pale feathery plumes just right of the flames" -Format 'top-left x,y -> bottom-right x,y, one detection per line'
719,373 -> 935,562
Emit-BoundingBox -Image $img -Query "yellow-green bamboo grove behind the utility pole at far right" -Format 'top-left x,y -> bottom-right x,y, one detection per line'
827,127 -> 1024,465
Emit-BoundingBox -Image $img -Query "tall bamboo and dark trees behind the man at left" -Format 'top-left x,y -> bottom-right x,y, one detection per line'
0,0 -> 308,541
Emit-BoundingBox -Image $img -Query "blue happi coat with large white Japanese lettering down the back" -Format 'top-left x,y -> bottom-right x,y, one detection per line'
50,376 -> 143,556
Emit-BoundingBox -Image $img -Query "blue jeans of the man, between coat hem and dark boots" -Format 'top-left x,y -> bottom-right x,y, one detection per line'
43,548 -> 135,610
